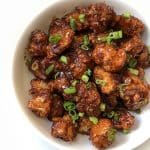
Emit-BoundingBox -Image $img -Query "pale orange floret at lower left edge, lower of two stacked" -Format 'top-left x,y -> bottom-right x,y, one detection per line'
27,95 -> 51,117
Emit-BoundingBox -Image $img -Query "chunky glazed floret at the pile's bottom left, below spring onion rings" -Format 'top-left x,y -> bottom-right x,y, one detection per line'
51,115 -> 77,141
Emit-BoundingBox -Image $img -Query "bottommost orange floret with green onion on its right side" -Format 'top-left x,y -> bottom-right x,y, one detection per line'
90,119 -> 116,149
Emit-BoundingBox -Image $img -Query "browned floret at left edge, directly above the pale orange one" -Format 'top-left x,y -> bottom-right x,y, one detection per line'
29,79 -> 50,96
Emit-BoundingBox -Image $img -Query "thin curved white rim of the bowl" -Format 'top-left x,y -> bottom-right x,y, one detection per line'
11,0 -> 150,150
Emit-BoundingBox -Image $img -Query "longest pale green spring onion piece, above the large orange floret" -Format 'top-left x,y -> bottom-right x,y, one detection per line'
98,30 -> 123,44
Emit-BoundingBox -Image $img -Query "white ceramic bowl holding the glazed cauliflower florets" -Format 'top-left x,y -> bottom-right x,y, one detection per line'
13,0 -> 150,150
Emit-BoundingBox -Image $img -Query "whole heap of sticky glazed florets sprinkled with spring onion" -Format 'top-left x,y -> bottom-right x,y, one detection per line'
26,3 -> 149,149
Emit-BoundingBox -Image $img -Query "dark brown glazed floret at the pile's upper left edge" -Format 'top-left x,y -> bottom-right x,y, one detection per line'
27,30 -> 48,56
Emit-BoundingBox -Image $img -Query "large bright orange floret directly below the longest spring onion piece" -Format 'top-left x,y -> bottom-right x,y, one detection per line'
92,44 -> 126,72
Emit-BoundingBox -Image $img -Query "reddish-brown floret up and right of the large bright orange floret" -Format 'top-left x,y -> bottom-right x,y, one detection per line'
121,35 -> 144,56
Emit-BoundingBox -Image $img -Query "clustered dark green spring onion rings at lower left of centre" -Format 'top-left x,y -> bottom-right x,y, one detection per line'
63,101 -> 79,123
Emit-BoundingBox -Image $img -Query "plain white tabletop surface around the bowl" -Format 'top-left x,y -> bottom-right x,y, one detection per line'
0,0 -> 150,150
